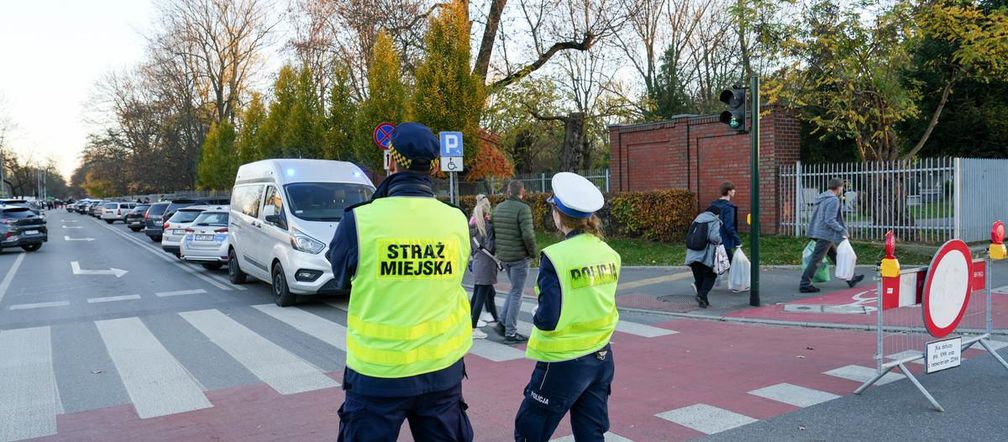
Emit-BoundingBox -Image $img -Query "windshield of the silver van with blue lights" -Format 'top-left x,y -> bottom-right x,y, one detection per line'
284,183 -> 374,221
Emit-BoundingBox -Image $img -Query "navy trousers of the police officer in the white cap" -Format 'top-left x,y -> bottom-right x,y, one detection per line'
514,345 -> 615,442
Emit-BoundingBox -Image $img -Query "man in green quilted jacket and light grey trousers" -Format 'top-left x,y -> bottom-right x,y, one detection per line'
491,180 -> 537,343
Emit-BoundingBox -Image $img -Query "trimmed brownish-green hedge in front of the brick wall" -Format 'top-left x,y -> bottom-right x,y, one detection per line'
459,189 -> 697,242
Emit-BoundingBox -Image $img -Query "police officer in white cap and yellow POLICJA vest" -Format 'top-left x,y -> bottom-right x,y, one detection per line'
514,173 -> 620,442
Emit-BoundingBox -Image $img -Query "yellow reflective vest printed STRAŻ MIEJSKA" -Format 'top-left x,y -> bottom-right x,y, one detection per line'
347,197 -> 473,377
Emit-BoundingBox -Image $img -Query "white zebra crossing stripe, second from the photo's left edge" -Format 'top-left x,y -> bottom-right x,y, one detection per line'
95,318 -> 213,419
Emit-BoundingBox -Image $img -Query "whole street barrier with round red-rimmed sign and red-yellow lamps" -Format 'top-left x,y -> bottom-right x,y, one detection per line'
854,226 -> 1008,411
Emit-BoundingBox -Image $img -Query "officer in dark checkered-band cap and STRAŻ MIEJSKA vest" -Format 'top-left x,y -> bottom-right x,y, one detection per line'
327,123 -> 473,442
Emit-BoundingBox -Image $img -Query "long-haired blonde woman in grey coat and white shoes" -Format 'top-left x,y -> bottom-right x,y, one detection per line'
469,195 -> 501,339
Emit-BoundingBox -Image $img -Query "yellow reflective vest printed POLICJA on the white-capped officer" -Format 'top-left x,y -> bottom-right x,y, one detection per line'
525,233 -> 620,362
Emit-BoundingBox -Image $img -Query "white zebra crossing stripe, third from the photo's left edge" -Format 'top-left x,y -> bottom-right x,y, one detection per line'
179,310 -> 339,395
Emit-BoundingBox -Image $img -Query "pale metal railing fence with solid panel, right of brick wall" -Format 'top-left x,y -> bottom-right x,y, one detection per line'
778,158 -> 1008,243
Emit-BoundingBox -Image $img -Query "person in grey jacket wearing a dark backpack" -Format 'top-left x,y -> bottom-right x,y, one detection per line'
686,206 -> 721,309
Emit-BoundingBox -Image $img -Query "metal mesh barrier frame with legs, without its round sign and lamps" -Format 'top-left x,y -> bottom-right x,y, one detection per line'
854,258 -> 1008,411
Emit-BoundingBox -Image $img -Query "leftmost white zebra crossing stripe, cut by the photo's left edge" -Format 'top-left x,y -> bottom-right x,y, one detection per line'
0,327 -> 61,440
